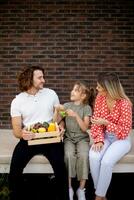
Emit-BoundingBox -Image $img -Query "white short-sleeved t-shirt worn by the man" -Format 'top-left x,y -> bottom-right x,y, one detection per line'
11,88 -> 59,127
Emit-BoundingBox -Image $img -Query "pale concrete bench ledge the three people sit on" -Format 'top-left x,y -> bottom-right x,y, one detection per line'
0,129 -> 134,174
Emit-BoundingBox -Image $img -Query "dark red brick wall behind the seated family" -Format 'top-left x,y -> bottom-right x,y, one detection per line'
0,0 -> 134,128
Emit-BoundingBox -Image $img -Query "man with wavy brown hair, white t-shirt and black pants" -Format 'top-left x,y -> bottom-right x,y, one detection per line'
9,66 -> 69,200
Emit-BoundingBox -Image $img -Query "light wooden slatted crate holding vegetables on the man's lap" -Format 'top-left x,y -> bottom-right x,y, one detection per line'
28,123 -> 61,145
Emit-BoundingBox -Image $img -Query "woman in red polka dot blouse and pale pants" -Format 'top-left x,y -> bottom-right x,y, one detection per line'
89,73 -> 132,200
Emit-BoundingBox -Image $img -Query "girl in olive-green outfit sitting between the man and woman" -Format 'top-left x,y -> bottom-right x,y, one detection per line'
54,82 -> 94,200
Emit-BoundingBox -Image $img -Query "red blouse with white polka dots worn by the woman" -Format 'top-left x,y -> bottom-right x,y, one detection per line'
91,95 -> 132,143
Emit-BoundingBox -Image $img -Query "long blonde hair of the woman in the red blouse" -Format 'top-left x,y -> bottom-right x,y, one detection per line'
97,72 -> 132,104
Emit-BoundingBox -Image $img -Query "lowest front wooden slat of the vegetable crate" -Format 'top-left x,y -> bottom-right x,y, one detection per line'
28,136 -> 61,145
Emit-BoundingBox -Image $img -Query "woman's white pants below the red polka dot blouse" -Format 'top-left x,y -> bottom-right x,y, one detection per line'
89,133 -> 131,197
